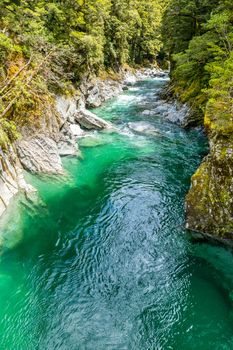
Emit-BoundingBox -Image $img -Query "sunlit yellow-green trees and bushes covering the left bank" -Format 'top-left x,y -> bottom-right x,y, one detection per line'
0,0 -> 164,141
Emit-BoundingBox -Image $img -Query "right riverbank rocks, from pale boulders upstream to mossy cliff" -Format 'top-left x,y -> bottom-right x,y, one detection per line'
163,81 -> 233,246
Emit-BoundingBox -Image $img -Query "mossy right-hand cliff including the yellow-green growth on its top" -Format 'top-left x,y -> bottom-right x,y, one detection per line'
186,85 -> 233,239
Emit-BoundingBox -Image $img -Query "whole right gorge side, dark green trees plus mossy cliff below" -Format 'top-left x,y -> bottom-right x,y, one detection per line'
163,0 -> 233,239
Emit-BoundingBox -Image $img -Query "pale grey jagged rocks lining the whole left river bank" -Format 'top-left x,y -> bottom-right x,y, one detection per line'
0,69 -> 164,216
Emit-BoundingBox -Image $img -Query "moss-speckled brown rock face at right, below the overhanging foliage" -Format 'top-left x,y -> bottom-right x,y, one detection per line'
186,139 -> 233,239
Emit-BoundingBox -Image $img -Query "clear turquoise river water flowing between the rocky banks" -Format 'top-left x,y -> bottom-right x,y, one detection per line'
0,80 -> 233,350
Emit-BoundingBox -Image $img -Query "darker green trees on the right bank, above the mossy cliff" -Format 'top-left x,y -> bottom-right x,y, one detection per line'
163,0 -> 233,126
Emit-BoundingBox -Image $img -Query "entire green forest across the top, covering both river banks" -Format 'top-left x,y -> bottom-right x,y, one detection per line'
0,0 -> 233,143
